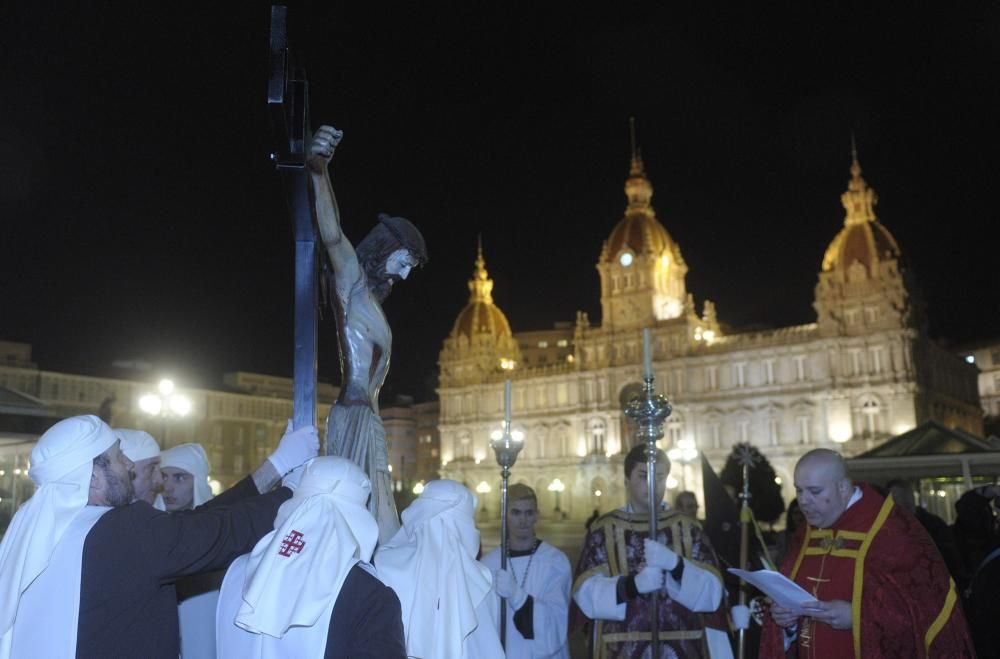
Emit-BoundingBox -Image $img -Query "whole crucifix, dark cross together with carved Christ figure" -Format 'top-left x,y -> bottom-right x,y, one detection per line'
267,5 -> 427,542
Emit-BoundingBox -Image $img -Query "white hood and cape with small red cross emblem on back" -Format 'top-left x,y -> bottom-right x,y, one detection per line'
215,456 -> 379,659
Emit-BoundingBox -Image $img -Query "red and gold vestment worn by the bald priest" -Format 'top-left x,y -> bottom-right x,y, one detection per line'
760,485 -> 975,659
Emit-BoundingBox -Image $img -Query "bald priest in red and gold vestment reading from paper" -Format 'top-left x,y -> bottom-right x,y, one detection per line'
760,449 -> 975,659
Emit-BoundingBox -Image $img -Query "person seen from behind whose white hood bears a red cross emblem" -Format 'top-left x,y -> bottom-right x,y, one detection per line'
216,456 -> 406,659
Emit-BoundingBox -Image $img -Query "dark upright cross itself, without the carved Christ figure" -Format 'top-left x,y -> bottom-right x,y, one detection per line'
267,5 -> 318,436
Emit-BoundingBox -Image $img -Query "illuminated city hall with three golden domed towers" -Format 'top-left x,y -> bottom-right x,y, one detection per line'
438,150 -> 982,519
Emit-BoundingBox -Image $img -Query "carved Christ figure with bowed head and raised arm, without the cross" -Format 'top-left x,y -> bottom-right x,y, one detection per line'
306,126 -> 427,543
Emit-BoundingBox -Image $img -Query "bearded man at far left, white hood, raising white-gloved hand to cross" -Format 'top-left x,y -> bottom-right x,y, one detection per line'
0,415 -> 319,659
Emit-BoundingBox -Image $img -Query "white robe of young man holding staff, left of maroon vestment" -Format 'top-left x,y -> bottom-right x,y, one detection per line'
482,542 -> 573,659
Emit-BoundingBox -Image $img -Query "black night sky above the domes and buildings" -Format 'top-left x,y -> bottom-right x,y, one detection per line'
0,2 -> 1000,399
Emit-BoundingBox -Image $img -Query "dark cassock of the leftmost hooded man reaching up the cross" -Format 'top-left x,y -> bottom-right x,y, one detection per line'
76,478 -> 292,659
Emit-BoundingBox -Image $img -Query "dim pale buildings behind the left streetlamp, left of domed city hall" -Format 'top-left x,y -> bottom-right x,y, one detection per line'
0,341 -> 441,527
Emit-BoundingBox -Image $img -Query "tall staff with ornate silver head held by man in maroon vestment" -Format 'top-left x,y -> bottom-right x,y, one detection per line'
625,328 -> 672,659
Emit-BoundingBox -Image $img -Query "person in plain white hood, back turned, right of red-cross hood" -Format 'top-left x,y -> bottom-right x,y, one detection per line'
375,480 -> 504,659
